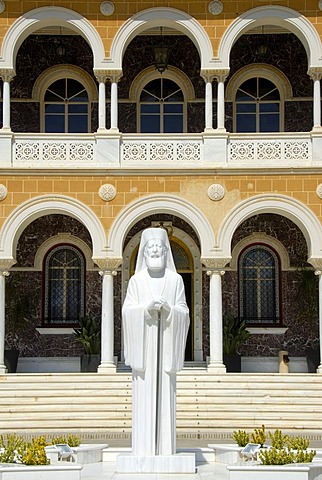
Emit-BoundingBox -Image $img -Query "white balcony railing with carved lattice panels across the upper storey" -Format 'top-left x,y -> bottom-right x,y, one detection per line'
0,131 -> 322,170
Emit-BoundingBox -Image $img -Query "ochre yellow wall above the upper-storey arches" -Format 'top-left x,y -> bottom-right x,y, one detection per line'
0,0 -> 322,57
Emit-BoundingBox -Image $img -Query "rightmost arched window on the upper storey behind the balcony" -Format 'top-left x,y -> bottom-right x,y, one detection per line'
235,76 -> 281,133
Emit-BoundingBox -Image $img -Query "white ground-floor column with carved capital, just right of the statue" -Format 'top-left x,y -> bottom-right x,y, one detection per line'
201,258 -> 229,373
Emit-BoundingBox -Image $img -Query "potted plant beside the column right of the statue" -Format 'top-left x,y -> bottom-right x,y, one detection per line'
223,314 -> 250,372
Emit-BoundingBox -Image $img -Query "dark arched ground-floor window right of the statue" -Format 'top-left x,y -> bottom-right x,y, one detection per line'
238,244 -> 281,326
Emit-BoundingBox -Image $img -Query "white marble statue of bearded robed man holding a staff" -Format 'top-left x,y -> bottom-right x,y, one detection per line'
123,228 -> 189,456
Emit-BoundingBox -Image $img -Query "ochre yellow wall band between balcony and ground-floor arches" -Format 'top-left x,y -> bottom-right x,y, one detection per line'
0,175 -> 322,234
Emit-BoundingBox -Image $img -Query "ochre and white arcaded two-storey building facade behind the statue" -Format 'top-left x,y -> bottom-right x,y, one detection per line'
0,0 -> 322,373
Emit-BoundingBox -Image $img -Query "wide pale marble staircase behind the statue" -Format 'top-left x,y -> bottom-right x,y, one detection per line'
0,368 -> 322,441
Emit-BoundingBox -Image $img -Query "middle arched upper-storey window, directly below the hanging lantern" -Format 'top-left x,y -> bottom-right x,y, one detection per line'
140,77 -> 184,133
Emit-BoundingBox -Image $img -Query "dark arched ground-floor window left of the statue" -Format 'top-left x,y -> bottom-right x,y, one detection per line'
44,245 -> 85,326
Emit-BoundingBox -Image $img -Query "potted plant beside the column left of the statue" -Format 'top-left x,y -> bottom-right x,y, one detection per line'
74,317 -> 101,372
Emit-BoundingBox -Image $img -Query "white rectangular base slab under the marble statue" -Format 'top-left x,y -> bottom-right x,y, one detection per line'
116,453 -> 196,473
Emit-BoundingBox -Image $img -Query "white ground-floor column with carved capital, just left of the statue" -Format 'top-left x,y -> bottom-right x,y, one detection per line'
94,258 -> 122,373
